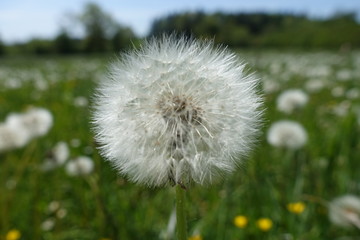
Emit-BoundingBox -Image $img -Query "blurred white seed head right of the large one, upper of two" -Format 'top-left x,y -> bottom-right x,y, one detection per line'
277,89 -> 309,114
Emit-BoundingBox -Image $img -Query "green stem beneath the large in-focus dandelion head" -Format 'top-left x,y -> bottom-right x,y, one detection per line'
176,184 -> 187,240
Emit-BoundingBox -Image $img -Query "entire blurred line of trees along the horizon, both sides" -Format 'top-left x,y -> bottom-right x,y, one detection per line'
0,3 -> 360,55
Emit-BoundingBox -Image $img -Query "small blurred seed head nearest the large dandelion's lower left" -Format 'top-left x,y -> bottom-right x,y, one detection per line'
65,156 -> 94,176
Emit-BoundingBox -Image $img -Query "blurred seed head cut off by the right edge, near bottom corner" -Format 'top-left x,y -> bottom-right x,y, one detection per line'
329,195 -> 360,229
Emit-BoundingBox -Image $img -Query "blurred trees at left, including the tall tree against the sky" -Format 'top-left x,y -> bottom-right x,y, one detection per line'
0,3 -> 138,55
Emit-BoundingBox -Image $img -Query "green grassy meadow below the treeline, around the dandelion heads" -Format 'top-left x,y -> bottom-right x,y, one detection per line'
0,50 -> 360,240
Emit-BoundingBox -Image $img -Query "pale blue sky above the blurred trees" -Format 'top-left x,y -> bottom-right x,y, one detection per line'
0,0 -> 360,42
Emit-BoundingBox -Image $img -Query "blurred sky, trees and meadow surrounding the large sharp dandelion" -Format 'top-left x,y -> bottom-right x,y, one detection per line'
0,0 -> 360,240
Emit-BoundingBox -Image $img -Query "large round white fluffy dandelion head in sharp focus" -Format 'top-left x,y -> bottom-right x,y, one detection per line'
93,36 -> 261,186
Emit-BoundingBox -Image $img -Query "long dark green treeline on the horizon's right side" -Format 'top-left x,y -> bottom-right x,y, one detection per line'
150,11 -> 360,48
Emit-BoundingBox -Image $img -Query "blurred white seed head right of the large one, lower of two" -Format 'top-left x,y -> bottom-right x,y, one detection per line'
267,120 -> 307,150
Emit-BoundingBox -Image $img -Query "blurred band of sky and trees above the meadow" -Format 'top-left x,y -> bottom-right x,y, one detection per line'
0,0 -> 360,54
